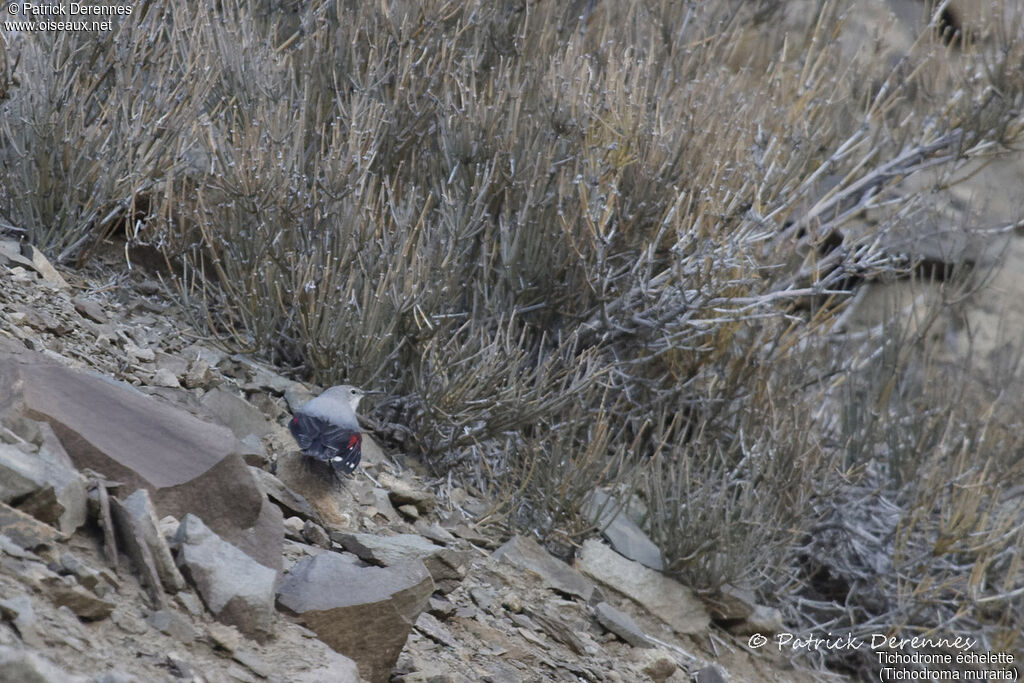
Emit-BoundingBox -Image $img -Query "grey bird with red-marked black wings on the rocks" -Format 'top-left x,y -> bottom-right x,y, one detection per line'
288,384 -> 377,476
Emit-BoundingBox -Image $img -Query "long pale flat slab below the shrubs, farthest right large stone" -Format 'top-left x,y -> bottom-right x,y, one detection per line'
578,539 -> 711,635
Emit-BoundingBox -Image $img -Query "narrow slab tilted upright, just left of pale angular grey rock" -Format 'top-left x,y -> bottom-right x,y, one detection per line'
111,488 -> 185,593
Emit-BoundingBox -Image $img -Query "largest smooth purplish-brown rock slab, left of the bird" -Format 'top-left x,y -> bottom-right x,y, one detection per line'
0,353 -> 284,570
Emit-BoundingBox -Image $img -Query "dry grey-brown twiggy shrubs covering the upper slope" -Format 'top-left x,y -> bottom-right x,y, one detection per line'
0,0 -> 1024,666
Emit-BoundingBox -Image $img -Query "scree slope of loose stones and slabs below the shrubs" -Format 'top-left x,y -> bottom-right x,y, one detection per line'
0,240 -> 831,682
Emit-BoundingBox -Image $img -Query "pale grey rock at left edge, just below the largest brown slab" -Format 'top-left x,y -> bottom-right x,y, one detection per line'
0,443 -> 88,535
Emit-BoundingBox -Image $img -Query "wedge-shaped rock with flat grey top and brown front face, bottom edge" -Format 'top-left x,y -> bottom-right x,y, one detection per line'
278,553 -> 434,683
